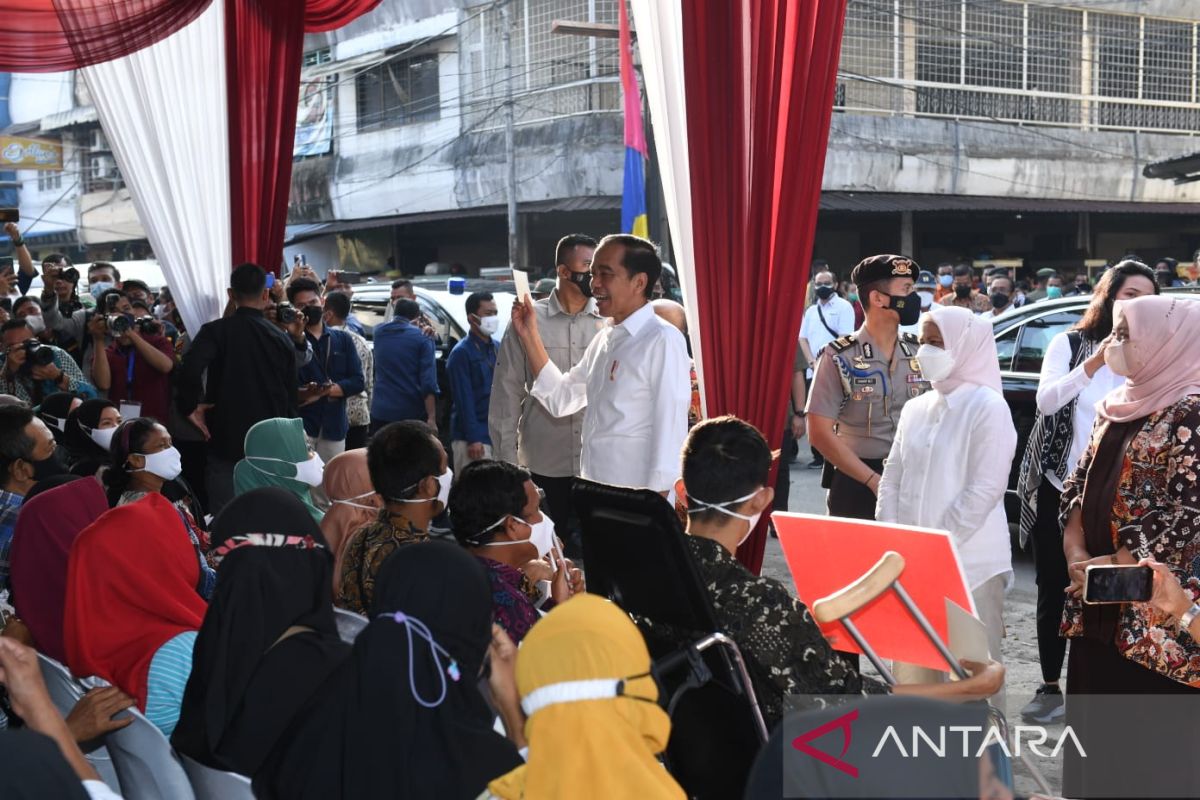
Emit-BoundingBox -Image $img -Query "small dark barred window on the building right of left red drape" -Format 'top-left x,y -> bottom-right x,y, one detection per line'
354,55 -> 442,131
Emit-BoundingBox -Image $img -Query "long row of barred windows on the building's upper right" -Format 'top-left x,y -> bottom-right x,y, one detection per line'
838,0 -> 1200,133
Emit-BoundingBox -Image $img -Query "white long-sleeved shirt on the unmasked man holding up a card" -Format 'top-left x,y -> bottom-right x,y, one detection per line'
532,303 -> 691,492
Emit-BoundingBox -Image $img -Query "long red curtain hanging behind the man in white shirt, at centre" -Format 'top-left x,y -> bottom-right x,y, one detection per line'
683,0 -> 846,572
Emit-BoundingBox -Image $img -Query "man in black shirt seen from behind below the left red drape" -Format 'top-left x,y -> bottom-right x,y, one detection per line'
179,264 -> 312,515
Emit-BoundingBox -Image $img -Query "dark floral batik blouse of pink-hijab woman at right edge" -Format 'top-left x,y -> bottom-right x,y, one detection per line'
1061,395 -> 1200,687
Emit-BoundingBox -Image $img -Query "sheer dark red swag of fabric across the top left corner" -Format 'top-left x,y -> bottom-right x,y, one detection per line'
0,0 -> 211,72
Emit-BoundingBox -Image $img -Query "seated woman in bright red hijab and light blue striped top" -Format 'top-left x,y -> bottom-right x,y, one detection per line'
62,494 -> 206,736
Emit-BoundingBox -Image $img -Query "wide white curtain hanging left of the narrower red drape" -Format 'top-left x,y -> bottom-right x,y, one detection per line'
79,2 -> 232,336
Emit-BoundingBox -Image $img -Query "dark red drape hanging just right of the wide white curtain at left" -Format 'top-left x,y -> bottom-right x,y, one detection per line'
226,0 -> 379,271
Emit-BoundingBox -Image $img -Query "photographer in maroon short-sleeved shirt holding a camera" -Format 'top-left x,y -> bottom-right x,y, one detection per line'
88,289 -> 175,422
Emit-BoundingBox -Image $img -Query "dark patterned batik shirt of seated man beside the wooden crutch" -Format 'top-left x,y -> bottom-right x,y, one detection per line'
643,536 -> 888,728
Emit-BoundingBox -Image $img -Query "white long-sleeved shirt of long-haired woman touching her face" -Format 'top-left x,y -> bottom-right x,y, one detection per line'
1038,333 -> 1124,492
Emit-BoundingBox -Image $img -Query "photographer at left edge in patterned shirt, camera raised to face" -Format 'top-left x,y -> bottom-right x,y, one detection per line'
0,319 -> 96,405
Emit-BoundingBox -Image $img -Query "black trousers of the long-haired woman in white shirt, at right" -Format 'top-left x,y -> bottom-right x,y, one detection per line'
1030,477 -> 1070,684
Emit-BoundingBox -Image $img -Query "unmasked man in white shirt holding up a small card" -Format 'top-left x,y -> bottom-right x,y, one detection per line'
512,234 -> 691,494
